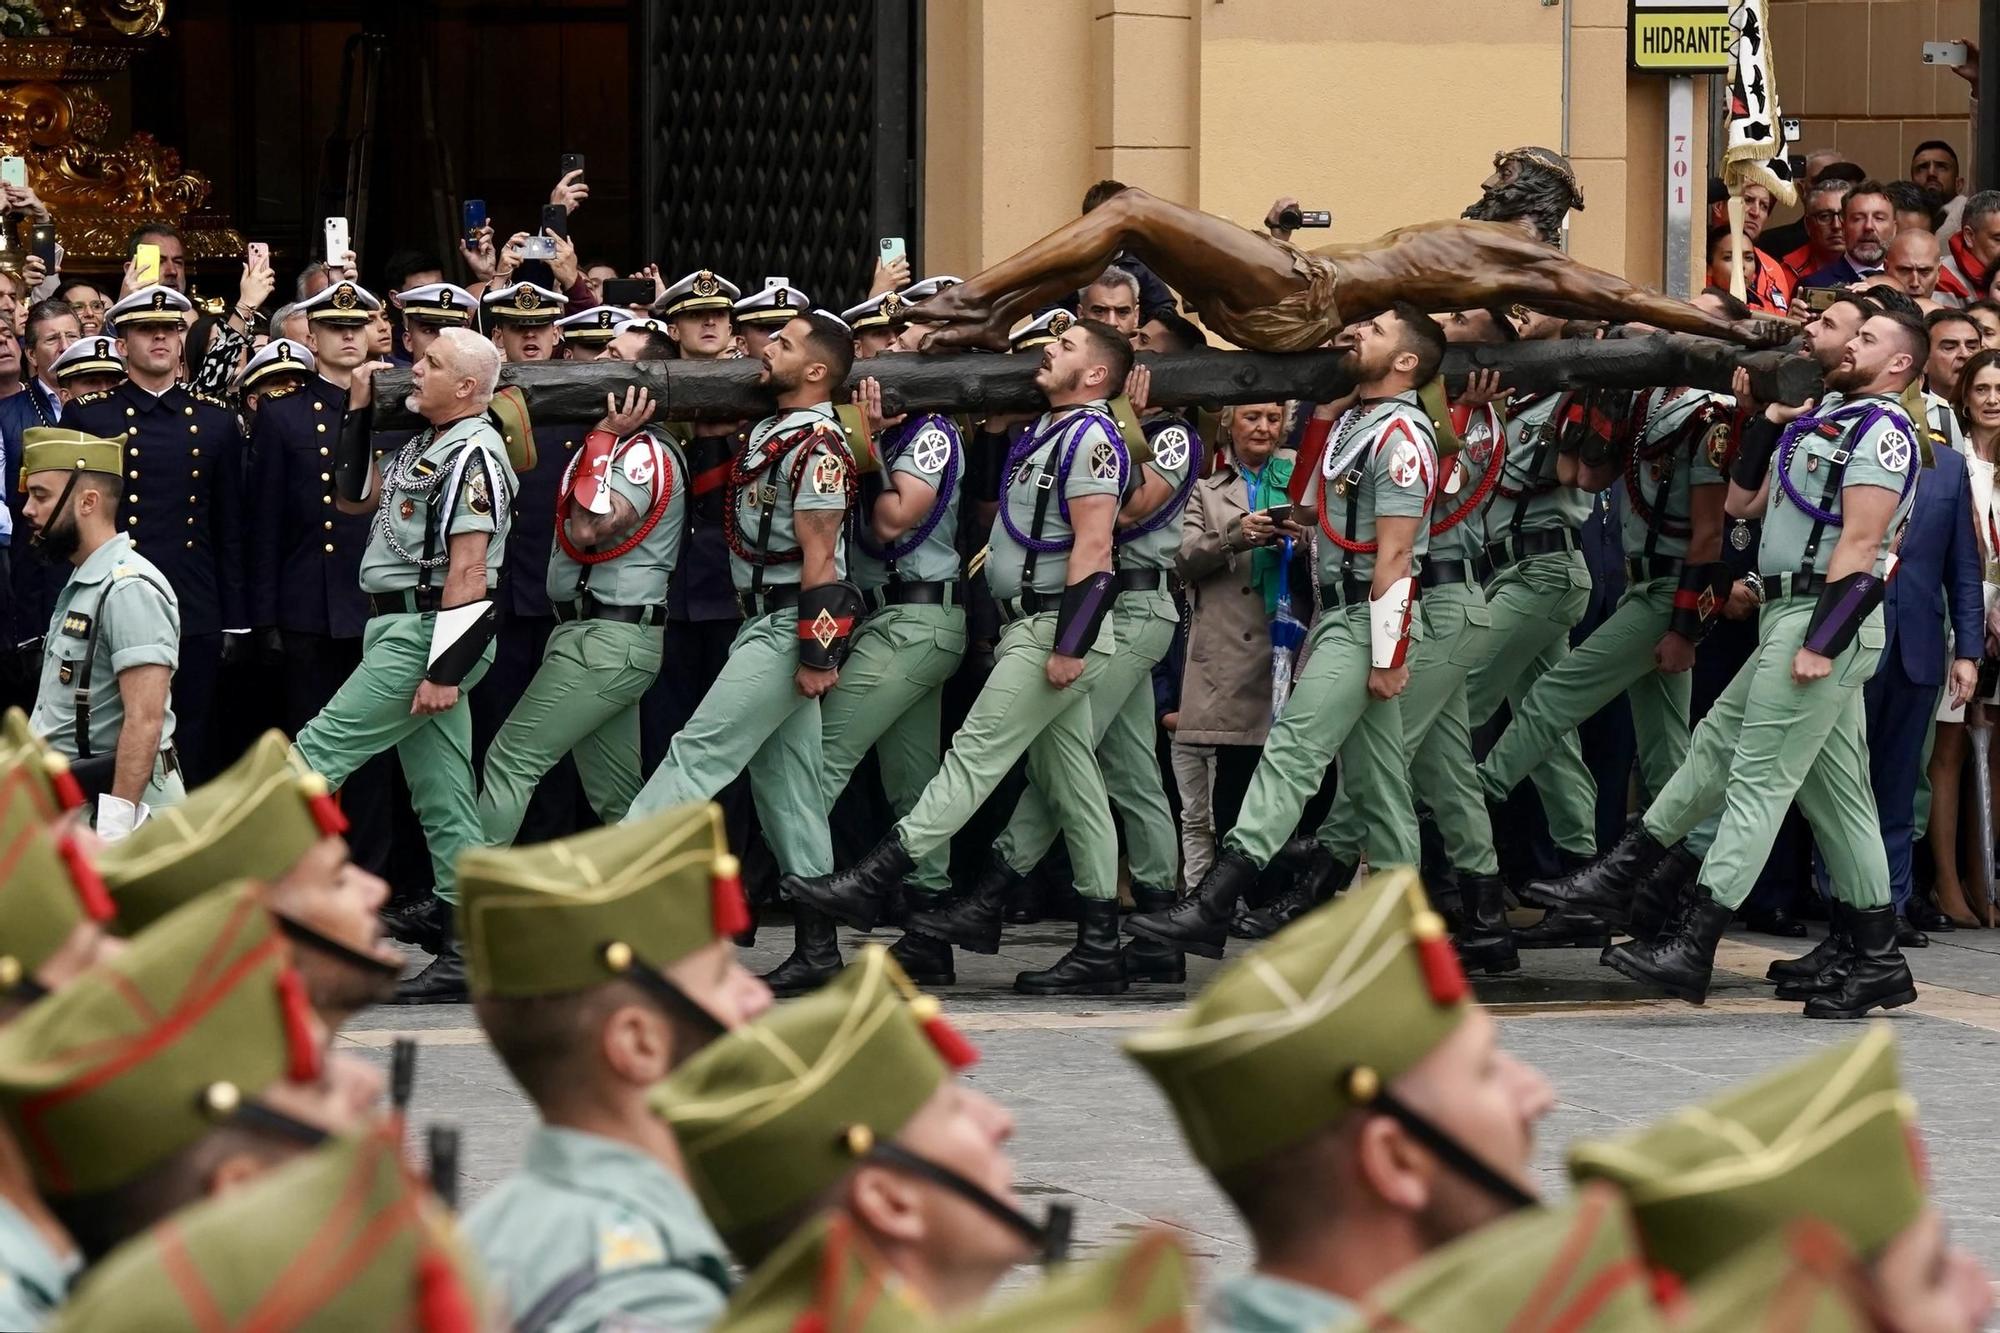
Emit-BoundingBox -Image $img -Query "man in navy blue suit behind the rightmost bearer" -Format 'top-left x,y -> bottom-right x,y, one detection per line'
1862,432 -> 1986,932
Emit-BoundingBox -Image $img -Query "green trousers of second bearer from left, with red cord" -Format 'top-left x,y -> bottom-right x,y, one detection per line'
480,620 -> 666,845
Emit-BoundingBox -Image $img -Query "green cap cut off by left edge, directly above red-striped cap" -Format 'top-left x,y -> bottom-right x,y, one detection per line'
0,751 -> 112,999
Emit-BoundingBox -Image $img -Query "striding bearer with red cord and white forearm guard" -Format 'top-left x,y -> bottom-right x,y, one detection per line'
1126,306 -> 1444,959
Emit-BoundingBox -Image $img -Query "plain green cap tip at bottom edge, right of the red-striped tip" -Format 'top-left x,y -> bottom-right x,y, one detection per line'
944,1227 -> 1194,1333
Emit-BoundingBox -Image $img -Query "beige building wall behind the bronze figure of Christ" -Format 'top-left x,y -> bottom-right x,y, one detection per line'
924,0 -> 1720,302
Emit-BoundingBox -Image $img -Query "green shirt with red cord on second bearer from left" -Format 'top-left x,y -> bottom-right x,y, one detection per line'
548,430 -> 690,606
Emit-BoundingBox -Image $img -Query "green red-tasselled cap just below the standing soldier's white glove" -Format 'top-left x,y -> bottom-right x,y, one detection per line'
98,731 -> 348,933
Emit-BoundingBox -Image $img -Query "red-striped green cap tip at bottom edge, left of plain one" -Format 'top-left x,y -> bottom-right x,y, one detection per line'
710,1211 -> 938,1333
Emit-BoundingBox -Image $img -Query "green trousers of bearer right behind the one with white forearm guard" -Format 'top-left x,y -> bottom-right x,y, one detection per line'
1318,582 -> 1500,875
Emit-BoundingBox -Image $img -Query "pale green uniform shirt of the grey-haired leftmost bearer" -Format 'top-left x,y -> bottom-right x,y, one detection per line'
362,416 -> 516,592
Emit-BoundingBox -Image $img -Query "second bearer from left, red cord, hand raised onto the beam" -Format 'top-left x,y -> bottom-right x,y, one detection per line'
480,328 -> 688,843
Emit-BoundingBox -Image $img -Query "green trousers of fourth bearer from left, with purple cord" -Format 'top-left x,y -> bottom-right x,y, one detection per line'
820,604 -> 966,893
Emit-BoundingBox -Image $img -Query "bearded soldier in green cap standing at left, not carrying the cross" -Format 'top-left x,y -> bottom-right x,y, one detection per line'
20,426 -> 186,841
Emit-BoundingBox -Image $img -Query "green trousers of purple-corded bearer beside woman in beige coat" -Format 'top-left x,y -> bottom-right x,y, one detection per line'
996,592 -> 1180,889
